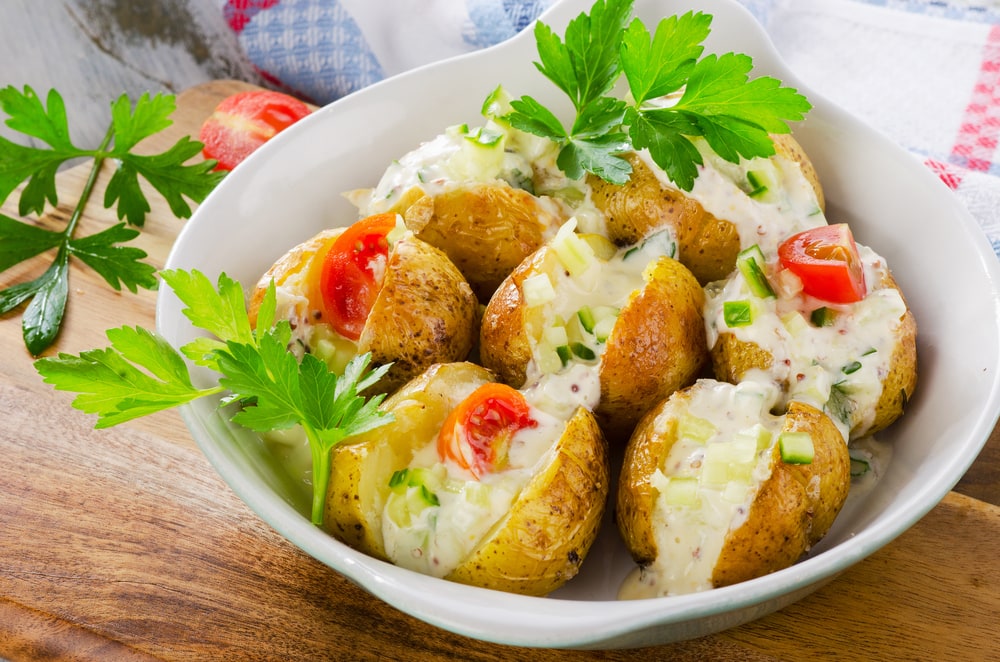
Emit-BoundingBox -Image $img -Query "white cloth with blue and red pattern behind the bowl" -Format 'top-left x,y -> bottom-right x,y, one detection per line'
216,0 -> 1000,257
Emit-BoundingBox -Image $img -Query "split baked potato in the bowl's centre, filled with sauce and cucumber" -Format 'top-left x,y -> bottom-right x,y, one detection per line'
479,224 -> 708,444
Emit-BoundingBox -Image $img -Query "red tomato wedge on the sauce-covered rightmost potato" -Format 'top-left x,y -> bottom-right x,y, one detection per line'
778,223 -> 867,303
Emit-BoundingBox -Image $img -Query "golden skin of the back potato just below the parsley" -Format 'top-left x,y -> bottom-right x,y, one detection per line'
587,153 -> 740,285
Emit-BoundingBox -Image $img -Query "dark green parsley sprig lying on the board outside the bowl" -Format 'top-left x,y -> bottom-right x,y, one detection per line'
0,86 -> 224,356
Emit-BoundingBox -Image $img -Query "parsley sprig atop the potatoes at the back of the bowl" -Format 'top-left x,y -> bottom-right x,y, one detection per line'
504,0 -> 811,191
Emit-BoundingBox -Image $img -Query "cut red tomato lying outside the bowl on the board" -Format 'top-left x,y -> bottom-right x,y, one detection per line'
198,90 -> 310,170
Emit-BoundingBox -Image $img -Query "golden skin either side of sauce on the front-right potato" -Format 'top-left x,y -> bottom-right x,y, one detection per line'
615,391 -> 850,587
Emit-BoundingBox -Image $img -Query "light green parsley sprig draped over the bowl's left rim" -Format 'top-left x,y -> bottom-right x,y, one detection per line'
34,270 -> 392,525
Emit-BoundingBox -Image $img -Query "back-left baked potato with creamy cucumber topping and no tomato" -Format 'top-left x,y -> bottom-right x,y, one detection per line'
349,120 -> 584,303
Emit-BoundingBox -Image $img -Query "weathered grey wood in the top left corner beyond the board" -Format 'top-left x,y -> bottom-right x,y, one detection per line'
0,0 -> 261,147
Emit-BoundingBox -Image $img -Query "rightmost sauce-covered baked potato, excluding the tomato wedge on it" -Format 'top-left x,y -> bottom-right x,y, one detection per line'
706,226 -> 917,439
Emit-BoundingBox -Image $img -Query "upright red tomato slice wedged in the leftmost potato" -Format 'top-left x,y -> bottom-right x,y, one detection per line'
319,214 -> 396,340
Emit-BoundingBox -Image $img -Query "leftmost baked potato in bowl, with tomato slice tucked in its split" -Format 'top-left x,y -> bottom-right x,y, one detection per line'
243,214 -> 478,393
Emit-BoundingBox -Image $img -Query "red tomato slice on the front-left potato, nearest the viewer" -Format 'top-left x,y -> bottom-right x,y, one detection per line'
438,382 -> 538,478
